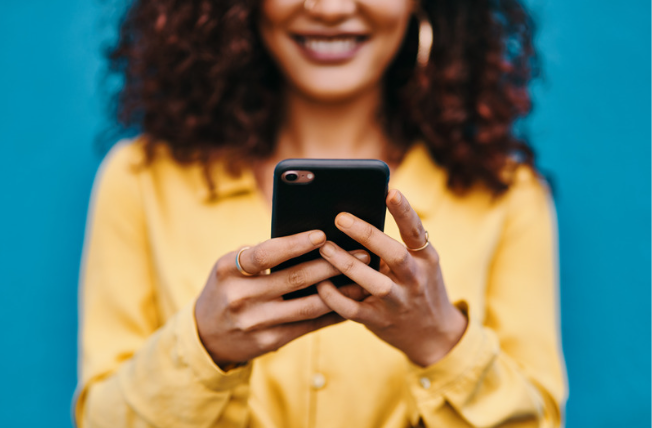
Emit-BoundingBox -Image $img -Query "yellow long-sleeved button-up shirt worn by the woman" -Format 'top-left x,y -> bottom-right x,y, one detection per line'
75,141 -> 567,428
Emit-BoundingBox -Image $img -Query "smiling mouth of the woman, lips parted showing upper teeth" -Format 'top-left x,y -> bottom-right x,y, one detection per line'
292,35 -> 369,62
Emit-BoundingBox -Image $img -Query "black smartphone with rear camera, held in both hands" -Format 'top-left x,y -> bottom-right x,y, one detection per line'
272,159 -> 389,299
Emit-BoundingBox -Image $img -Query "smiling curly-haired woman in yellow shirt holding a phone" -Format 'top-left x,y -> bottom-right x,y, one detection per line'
76,0 -> 565,427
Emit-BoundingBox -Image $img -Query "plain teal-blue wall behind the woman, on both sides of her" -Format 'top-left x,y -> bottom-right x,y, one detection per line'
0,0 -> 651,428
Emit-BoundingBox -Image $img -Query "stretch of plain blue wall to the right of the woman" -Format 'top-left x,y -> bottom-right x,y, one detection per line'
530,0 -> 650,428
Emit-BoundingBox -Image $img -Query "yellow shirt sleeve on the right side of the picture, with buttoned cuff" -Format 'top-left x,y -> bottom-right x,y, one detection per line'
408,171 -> 567,428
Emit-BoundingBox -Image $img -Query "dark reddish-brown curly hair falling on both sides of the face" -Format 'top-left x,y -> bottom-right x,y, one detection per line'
109,0 -> 538,195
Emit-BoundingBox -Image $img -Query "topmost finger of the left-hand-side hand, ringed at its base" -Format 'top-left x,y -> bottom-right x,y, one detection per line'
240,230 -> 326,274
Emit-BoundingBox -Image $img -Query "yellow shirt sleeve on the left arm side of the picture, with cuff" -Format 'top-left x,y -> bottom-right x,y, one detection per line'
74,144 -> 251,428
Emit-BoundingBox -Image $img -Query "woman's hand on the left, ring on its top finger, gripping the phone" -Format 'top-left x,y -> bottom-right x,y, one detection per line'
195,230 -> 370,368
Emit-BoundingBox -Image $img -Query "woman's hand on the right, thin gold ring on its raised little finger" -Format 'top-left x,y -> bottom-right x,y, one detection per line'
317,190 -> 467,367
